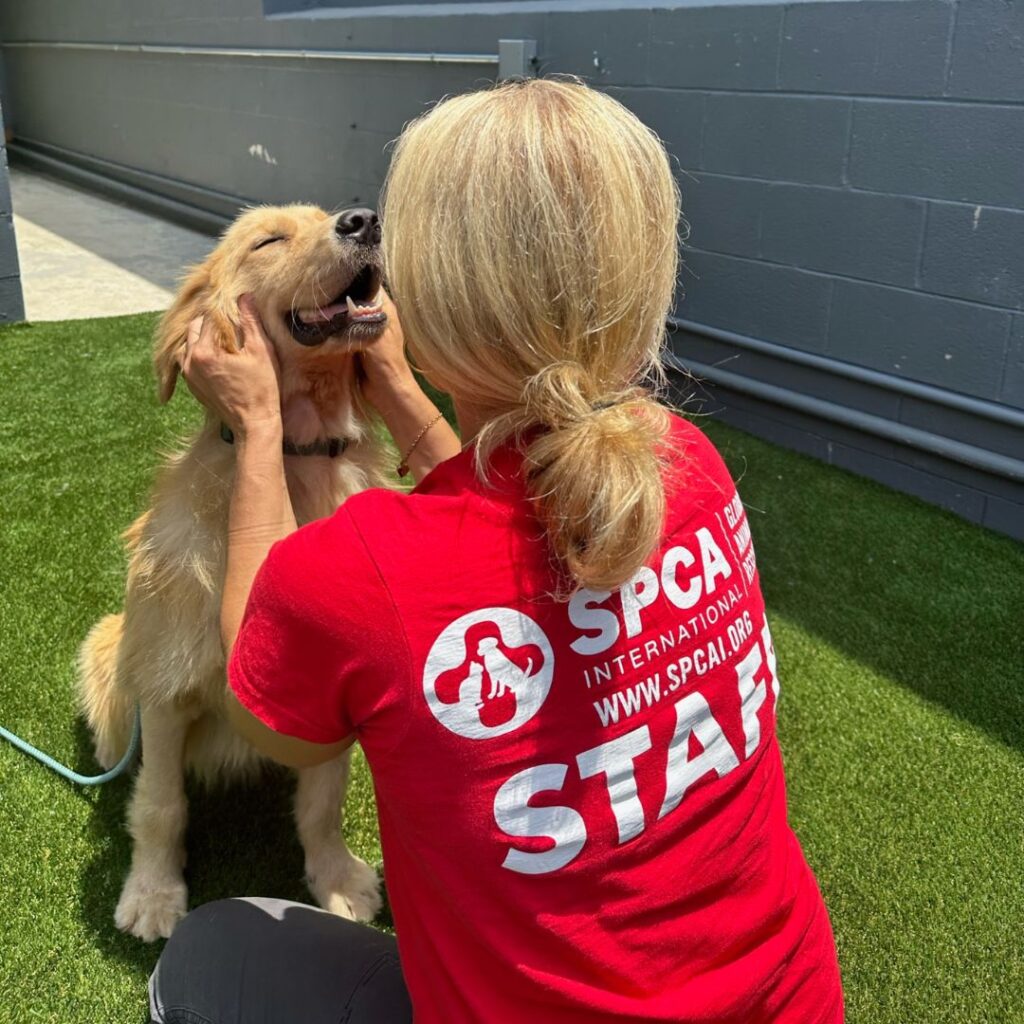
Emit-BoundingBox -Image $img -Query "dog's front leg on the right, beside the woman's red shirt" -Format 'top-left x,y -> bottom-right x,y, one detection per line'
295,751 -> 381,921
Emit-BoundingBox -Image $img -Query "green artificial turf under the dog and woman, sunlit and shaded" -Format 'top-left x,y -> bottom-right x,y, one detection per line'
0,315 -> 1024,1024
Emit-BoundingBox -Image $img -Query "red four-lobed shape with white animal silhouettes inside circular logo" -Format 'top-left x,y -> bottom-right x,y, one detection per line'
436,623 -> 544,728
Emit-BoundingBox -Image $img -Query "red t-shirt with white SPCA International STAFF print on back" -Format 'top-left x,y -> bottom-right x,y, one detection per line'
229,419 -> 843,1024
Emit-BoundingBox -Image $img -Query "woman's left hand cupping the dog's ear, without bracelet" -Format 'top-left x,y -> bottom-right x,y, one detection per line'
180,295 -> 281,436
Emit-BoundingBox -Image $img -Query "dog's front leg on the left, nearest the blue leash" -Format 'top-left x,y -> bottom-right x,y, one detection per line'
114,706 -> 189,942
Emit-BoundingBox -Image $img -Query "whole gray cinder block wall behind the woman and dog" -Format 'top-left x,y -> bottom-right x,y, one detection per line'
0,0 -> 1024,537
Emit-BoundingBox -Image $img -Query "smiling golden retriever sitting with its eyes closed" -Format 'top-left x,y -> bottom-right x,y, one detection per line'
79,206 -> 387,941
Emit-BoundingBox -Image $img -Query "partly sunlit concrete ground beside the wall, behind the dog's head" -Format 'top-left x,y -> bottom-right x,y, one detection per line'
10,168 -> 215,321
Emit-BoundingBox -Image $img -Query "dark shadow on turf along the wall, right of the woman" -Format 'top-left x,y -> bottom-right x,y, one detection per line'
698,418 -> 1024,750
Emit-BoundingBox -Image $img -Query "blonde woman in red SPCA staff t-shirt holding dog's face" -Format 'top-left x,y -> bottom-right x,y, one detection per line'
153,75 -> 843,1024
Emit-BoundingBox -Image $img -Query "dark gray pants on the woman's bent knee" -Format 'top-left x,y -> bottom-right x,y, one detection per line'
150,898 -> 413,1024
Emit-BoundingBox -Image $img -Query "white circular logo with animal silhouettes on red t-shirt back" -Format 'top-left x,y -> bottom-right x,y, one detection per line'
423,608 -> 555,739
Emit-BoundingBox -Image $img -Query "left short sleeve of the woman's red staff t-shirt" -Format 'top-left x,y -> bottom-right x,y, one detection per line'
227,508 -> 404,743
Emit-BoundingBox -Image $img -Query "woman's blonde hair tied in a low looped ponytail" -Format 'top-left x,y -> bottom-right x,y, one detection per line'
382,79 -> 680,590
